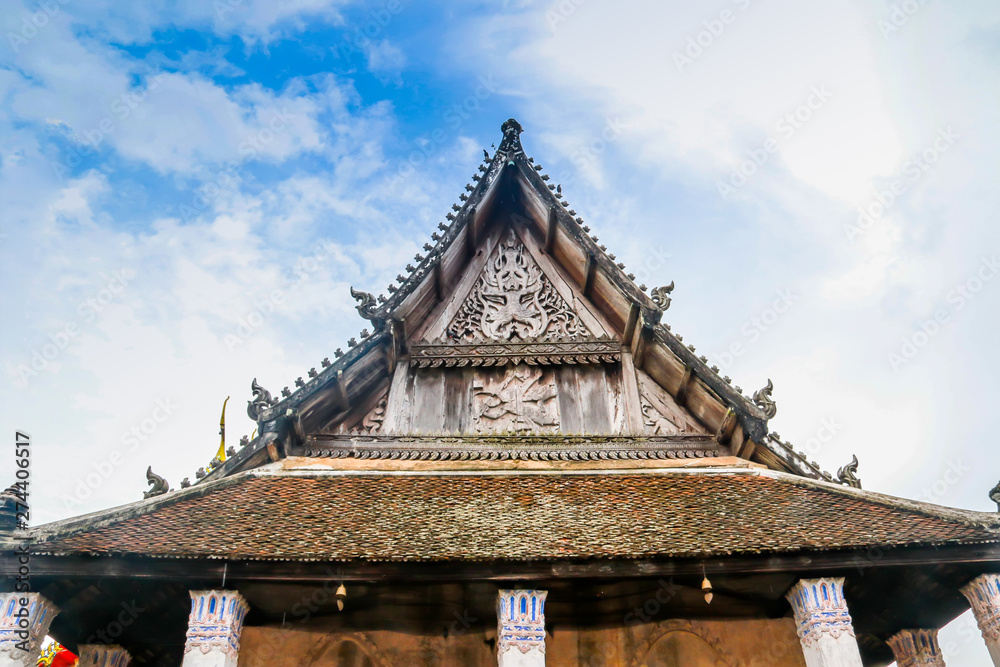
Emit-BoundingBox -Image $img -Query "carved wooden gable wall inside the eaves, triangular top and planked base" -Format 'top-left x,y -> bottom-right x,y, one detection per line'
320,224 -> 708,448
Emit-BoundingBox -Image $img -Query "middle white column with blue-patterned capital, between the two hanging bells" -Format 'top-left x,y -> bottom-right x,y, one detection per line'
497,590 -> 548,667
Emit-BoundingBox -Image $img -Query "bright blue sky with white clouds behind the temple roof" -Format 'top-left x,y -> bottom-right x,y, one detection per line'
0,0 -> 1000,665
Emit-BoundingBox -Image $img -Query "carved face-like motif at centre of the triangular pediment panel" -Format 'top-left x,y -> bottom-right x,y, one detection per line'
481,240 -> 549,340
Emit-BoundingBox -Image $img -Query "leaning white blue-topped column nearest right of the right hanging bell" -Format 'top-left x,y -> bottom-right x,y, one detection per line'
785,578 -> 862,667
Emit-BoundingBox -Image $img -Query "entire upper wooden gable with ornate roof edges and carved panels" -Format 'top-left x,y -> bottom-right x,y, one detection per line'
217,120 -> 844,480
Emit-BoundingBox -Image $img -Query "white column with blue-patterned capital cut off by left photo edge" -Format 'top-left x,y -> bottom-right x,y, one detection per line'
0,593 -> 59,667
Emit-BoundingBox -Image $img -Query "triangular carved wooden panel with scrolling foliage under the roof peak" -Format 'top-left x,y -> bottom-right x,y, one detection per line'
448,230 -> 591,342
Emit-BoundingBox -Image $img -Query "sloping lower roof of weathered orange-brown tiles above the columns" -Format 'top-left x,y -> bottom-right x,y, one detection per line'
34,471 -> 1000,561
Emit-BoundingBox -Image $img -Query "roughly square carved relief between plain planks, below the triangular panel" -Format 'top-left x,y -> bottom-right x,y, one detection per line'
472,366 -> 559,433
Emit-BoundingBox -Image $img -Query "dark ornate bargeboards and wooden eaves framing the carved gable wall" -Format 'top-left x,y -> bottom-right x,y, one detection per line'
209,119 -> 850,483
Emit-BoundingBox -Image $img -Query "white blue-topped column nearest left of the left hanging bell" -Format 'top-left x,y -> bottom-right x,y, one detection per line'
181,591 -> 250,667
